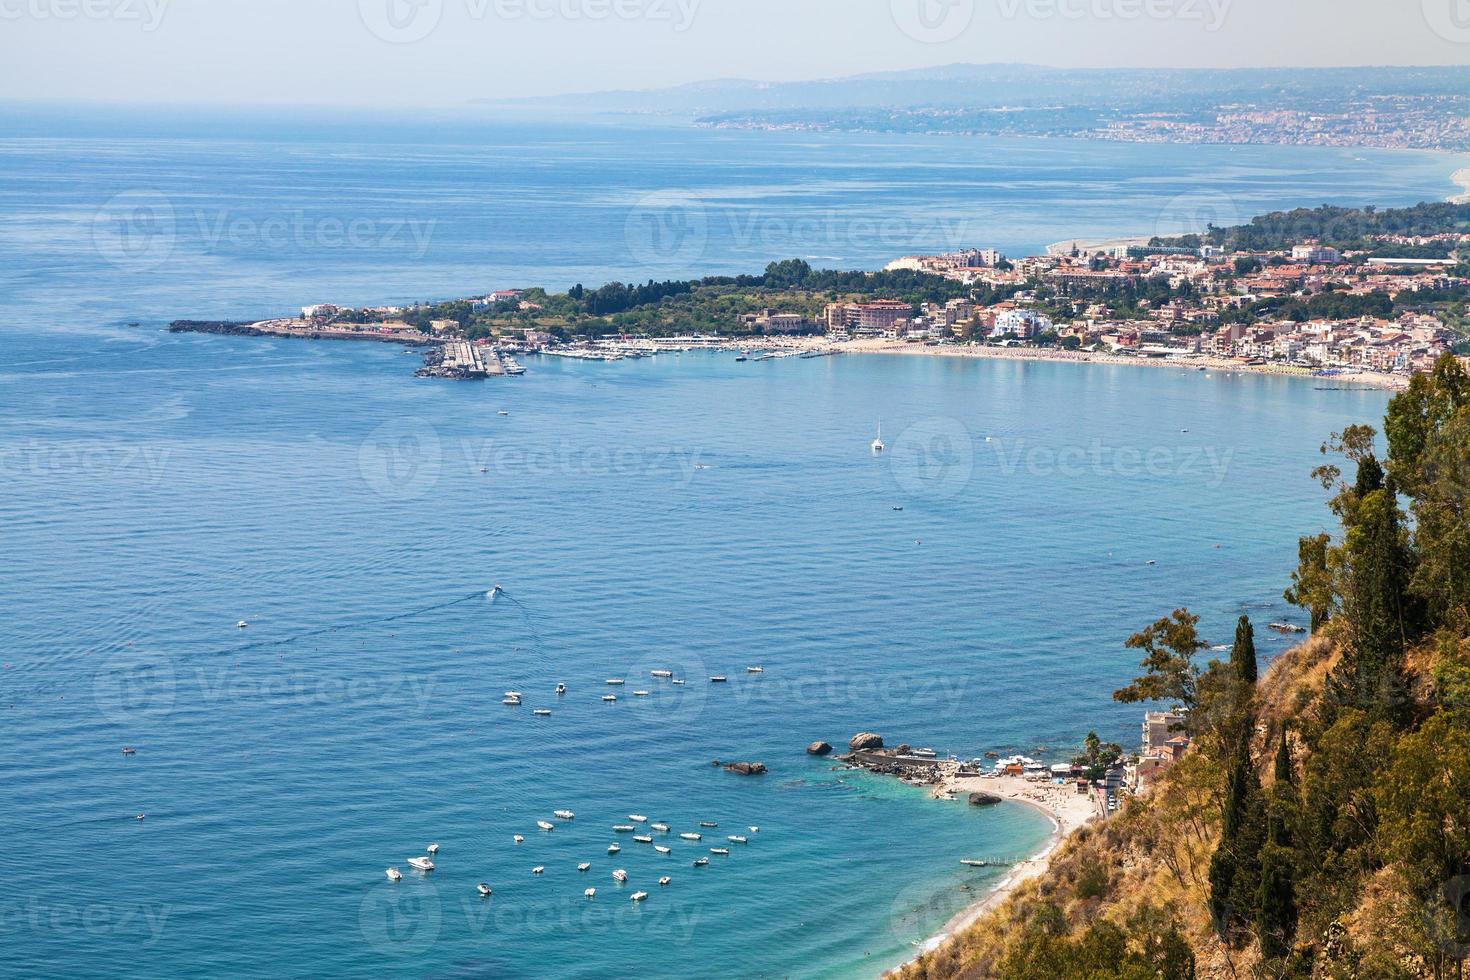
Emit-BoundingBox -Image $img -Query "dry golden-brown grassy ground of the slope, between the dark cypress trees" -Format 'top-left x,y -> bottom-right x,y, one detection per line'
892,630 -> 1470,980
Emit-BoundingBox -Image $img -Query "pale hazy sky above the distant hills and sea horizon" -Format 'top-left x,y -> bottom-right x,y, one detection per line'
0,0 -> 1470,107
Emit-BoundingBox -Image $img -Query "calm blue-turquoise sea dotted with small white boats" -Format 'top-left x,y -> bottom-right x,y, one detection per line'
0,106 -> 1466,977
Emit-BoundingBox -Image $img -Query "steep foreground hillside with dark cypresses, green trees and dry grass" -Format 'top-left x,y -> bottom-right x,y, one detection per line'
898,357 -> 1470,980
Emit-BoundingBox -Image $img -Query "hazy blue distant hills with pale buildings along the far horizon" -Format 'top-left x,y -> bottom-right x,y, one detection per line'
484,65 -> 1470,151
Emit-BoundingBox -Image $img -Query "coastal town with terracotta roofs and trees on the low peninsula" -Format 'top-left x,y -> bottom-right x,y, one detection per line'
171,196 -> 1470,388
